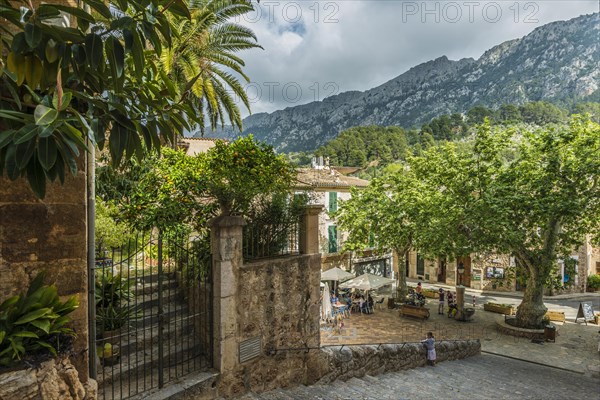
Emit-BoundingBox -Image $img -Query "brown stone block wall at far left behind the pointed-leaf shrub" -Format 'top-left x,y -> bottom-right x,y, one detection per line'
0,172 -> 88,381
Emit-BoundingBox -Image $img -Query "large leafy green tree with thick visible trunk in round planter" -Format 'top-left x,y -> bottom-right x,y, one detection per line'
410,118 -> 600,327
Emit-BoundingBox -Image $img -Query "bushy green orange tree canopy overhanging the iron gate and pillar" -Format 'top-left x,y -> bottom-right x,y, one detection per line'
96,135 -> 295,231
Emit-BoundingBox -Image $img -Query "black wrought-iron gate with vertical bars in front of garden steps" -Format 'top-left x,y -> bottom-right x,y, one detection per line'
90,231 -> 213,400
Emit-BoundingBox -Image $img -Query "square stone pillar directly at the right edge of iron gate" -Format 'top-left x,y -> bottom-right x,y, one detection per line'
211,216 -> 245,373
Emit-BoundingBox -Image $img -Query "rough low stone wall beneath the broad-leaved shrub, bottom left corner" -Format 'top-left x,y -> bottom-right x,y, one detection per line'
0,358 -> 97,400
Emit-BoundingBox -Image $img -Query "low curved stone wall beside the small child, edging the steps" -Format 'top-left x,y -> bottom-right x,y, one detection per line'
312,340 -> 481,383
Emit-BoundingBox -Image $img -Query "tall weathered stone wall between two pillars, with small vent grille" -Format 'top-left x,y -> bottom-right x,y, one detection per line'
218,254 -> 321,396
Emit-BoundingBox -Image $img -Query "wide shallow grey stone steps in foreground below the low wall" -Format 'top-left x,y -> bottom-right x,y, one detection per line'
237,354 -> 600,400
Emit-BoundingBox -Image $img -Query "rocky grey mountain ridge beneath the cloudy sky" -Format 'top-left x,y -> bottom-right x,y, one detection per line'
198,13 -> 600,152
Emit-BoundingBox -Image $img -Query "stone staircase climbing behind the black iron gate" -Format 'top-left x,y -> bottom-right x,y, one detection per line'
97,274 -> 211,400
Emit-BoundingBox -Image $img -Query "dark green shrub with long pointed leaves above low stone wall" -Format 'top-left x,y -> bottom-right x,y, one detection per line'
0,273 -> 79,366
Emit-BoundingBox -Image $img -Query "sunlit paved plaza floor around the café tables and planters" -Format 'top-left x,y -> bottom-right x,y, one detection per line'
321,299 -> 600,376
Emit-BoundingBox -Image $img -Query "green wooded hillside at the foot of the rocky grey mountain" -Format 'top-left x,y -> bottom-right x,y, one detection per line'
308,101 -> 600,173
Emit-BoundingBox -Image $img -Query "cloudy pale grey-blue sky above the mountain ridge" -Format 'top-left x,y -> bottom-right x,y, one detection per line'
227,0 -> 598,116
